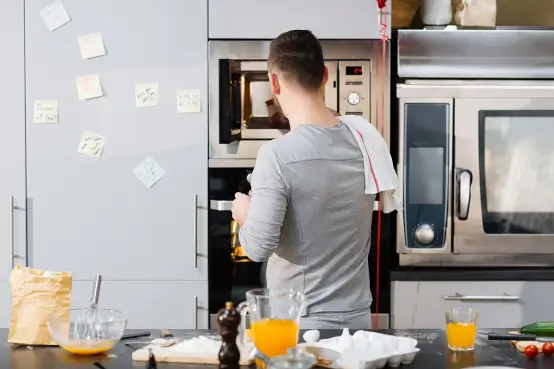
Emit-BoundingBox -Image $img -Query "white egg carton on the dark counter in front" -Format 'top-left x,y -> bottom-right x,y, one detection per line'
298,330 -> 419,369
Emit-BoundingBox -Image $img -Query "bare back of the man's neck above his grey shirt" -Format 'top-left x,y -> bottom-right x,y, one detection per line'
286,96 -> 340,130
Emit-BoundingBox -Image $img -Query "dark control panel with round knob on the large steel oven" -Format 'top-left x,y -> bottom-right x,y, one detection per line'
397,98 -> 453,254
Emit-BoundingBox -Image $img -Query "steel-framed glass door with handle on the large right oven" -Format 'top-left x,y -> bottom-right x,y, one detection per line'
453,98 -> 554,254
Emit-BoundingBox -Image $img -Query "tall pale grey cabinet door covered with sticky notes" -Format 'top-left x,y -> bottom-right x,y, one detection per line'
25,0 -> 208,281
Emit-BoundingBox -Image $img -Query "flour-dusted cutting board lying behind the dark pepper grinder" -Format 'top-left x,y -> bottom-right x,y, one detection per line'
132,345 -> 254,366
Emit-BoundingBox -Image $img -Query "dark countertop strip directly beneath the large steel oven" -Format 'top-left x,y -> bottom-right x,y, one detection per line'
390,267 -> 554,281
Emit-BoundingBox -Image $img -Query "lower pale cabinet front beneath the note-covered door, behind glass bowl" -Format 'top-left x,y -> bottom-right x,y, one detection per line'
71,281 -> 208,329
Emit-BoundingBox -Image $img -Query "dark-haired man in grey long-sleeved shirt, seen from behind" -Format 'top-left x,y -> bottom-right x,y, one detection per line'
232,30 -> 392,329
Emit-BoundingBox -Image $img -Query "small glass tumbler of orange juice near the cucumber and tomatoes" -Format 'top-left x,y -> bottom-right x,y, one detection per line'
446,308 -> 477,351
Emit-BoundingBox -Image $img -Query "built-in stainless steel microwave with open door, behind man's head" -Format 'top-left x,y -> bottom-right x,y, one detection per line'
209,40 -> 389,167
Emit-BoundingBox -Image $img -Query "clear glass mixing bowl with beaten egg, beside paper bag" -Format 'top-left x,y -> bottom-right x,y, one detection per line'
47,308 -> 127,355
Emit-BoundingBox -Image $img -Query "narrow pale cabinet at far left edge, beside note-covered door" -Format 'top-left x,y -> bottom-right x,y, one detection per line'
0,0 -> 27,328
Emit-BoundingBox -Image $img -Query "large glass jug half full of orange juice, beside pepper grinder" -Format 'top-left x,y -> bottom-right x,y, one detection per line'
237,288 -> 306,368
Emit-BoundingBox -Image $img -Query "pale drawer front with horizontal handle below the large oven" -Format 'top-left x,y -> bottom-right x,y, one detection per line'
391,281 -> 554,329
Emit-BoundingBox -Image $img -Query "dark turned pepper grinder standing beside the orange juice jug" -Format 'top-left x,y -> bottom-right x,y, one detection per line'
217,302 -> 240,369
